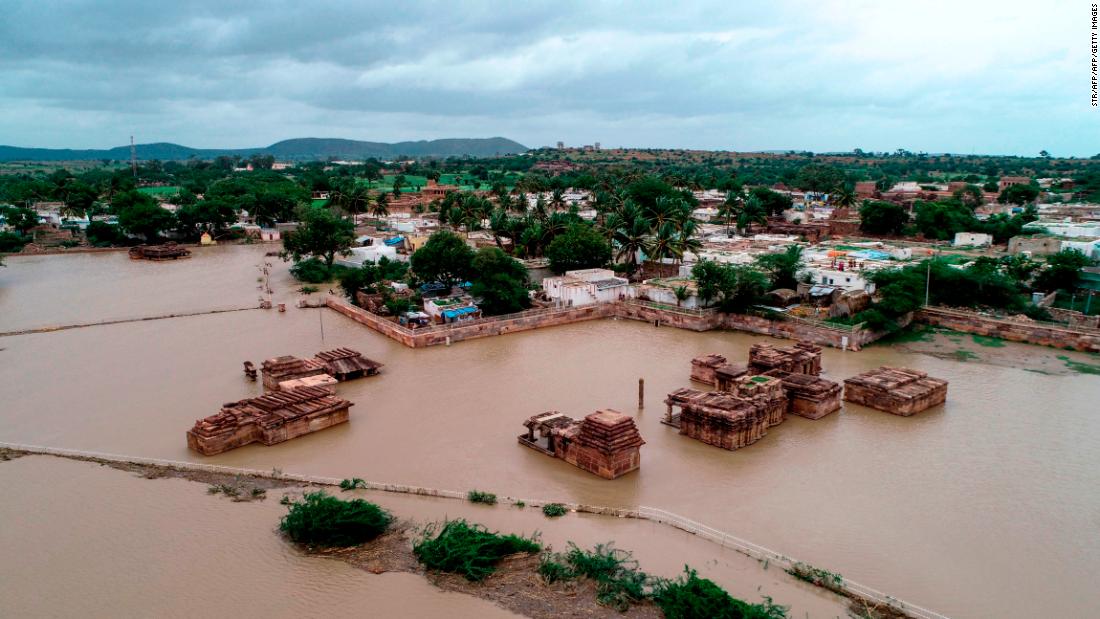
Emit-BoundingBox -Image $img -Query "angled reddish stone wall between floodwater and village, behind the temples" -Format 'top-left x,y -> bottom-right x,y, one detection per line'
325,297 -> 882,351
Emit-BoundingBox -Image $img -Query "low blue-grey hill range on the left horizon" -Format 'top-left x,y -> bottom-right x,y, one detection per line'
0,137 -> 527,162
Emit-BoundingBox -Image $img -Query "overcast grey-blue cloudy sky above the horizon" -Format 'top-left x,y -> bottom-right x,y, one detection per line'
0,0 -> 1100,156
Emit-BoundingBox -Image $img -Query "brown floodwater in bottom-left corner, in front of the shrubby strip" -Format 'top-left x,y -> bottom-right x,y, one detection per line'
0,456 -> 516,619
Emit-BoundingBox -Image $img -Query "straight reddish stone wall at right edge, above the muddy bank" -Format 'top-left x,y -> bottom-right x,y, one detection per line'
914,308 -> 1100,353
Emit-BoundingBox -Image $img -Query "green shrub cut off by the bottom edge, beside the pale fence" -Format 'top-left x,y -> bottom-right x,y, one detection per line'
653,567 -> 787,619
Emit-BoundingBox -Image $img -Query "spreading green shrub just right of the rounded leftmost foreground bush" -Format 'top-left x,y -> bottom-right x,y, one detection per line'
413,520 -> 541,582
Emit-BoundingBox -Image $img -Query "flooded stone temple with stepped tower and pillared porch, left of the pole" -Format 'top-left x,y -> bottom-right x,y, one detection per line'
519,409 -> 646,479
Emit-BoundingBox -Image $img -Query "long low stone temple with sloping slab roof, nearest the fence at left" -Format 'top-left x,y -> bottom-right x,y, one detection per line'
187,387 -> 352,455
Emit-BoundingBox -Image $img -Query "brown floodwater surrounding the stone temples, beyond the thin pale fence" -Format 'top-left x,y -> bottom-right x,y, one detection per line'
0,247 -> 1100,617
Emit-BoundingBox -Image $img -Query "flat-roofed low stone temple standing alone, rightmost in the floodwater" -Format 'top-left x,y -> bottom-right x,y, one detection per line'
844,366 -> 947,417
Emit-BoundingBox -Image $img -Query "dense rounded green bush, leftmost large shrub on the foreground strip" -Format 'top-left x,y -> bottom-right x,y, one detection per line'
279,491 -> 394,546
